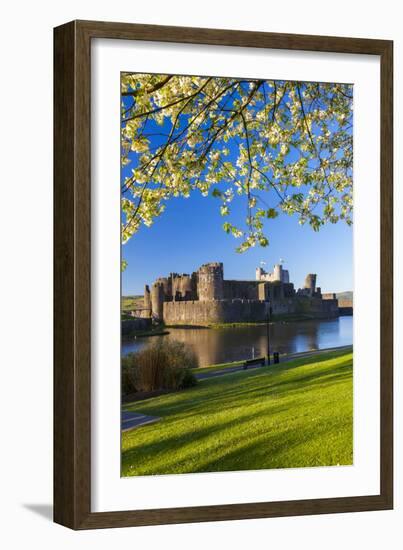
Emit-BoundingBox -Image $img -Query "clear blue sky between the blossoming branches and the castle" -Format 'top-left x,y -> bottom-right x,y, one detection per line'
122,192 -> 353,295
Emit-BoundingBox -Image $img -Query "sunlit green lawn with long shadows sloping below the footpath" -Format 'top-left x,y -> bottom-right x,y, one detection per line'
122,351 -> 353,476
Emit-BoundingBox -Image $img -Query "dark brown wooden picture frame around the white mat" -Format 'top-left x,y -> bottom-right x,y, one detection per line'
54,21 -> 393,529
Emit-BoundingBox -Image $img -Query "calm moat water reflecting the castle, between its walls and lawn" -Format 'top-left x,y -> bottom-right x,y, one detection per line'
122,316 -> 353,367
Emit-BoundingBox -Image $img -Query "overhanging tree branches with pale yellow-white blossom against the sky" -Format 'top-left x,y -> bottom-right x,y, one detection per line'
121,73 -> 353,252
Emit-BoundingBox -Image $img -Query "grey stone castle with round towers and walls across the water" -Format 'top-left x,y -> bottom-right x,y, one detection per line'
137,262 -> 338,325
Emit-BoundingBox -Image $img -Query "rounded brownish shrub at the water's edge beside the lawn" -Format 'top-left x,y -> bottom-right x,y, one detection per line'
122,340 -> 199,394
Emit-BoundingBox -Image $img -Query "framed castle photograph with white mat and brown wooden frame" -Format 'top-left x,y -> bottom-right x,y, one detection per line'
54,21 -> 393,529
